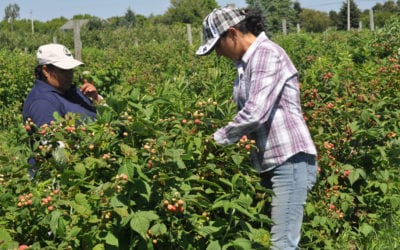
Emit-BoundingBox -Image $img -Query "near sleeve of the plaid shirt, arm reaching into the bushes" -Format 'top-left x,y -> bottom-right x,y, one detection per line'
214,39 -> 297,145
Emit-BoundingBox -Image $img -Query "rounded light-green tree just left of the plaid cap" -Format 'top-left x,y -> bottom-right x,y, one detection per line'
163,0 -> 218,24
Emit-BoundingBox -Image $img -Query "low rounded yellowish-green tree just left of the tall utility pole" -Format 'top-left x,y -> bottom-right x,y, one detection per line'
299,9 -> 330,32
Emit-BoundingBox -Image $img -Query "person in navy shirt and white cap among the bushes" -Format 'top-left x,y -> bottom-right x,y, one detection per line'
23,44 -> 102,127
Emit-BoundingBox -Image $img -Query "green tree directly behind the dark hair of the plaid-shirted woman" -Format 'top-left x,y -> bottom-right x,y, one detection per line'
246,0 -> 297,35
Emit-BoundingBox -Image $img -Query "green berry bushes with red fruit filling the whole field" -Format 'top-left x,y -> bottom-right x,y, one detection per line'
0,11 -> 400,249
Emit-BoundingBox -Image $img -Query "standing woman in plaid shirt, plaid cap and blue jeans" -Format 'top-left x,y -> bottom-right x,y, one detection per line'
196,8 -> 317,249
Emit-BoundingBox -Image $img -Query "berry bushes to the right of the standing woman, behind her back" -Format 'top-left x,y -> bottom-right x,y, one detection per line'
281,21 -> 400,249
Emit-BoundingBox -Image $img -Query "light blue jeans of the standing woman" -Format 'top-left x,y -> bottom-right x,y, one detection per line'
261,153 -> 317,250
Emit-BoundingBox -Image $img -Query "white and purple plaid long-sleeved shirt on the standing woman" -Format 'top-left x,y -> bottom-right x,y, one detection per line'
214,32 -> 316,171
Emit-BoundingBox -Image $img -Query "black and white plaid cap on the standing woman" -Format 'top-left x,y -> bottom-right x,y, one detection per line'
196,7 -> 246,56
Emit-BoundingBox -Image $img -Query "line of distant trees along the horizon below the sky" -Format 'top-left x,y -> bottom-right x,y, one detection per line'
0,0 -> 400,35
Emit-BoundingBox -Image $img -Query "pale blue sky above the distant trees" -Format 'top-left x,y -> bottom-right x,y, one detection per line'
0,0 -> 386,21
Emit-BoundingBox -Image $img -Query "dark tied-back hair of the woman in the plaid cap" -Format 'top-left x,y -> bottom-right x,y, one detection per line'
234,8 -> 265,36
